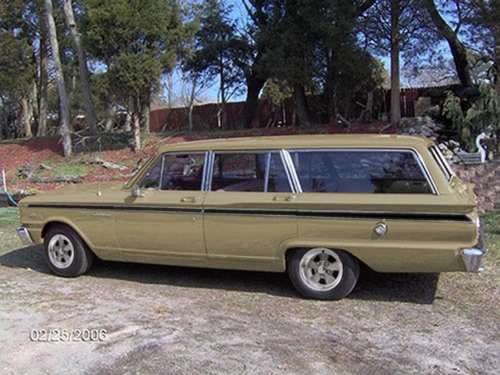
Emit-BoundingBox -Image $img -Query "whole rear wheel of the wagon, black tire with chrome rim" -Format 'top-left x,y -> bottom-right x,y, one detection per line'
287,248 -> 359,300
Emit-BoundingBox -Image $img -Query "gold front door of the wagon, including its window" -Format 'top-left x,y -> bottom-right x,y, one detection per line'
116,153 -> 206,263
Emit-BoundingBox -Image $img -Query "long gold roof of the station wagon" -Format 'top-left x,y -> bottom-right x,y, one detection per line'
159,134 -> 433,153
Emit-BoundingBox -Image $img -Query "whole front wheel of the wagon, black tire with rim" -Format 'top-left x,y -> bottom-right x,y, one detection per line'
44,225 -> 94,277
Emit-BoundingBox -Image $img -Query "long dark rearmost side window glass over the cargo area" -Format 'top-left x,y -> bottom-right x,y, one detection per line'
290,150 -> 432,194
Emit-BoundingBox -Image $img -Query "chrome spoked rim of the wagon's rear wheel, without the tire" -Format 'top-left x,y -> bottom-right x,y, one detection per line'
299,248 -> 344,292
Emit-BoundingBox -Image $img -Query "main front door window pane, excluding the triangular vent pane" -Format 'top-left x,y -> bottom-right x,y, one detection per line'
161,153 -> 205,190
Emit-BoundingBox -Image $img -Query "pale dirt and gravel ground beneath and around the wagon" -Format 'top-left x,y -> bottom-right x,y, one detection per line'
0,212 -> 500,374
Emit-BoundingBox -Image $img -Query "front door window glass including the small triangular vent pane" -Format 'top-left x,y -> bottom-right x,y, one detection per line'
139,153 -> 205,190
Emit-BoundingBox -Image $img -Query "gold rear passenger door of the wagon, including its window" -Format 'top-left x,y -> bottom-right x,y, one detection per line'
204,151 -> 297,268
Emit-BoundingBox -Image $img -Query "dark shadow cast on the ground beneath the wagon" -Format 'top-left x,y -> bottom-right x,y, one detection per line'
0,246 -> 439,304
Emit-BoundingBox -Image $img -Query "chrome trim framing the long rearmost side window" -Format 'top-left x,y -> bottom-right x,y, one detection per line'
286,147 -> 439,195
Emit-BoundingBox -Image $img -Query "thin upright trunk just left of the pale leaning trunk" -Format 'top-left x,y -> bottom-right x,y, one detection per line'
37,6 -> 49,137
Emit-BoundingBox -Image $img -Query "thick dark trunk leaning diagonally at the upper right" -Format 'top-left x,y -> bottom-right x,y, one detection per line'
423,0 -> 472,87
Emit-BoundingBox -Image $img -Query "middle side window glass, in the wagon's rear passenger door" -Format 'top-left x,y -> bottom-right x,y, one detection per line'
211,152 -> 291,192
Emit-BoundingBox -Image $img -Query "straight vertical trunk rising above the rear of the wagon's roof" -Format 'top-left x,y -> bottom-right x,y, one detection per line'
391,0 -> 401,125
